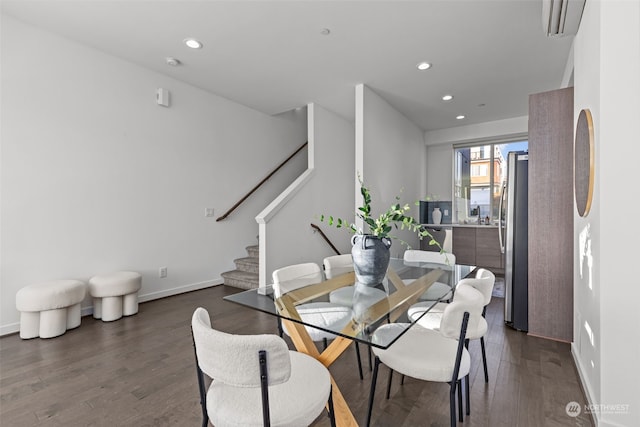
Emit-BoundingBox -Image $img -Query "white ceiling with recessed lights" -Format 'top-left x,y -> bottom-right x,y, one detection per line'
2,0 -> 573,130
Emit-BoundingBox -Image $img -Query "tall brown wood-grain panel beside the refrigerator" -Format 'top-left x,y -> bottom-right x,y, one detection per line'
528,87 -> 573,342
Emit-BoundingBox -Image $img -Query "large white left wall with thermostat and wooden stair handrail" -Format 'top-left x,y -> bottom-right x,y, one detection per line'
0,15 -> 307,334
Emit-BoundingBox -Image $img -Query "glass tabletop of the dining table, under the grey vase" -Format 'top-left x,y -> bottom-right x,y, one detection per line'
224,258 -> 476,349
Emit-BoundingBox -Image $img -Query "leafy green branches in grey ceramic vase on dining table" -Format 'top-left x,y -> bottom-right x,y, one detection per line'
320,179 -> 442,286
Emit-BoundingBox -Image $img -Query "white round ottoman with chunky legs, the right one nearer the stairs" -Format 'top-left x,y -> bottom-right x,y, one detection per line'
89,271 -> 142,322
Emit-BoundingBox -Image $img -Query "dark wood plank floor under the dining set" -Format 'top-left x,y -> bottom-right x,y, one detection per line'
0,286 -> 592,427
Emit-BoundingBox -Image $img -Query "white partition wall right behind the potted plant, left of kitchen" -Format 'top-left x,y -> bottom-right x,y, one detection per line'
356,85 -> 426,257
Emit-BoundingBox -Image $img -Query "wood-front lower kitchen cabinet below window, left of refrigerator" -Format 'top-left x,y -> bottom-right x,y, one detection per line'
453,225 -> 504,274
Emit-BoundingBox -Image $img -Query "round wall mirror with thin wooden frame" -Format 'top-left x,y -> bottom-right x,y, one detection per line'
573,109 -> 595,216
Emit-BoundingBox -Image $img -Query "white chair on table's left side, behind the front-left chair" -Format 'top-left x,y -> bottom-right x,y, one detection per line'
272,262 -> 363,379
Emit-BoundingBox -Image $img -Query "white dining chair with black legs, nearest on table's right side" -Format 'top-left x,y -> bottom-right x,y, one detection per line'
366,289 -> 482,426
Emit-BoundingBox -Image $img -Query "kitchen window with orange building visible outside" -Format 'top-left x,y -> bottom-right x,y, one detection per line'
453,138 -> 529,224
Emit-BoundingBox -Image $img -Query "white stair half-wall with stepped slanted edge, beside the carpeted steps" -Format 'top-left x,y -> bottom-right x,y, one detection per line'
257,104 -> 355,286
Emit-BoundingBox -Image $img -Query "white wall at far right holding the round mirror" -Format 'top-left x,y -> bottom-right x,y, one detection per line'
572,0 -> 640,426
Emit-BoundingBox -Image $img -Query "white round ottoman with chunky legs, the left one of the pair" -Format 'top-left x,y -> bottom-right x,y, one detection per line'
16,280 -> 86,339
